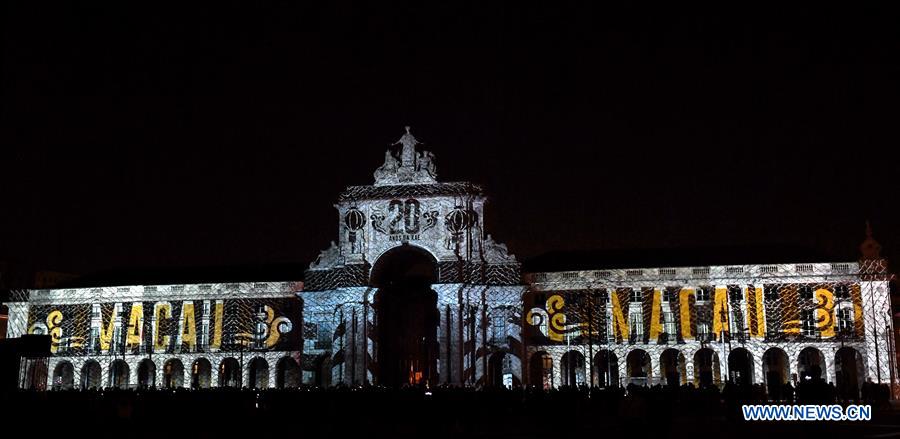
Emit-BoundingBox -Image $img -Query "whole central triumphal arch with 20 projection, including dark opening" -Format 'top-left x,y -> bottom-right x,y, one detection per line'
302,128 -> 525,385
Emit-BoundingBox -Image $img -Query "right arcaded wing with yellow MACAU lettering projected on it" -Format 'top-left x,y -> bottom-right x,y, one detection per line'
523,260 -> 892,392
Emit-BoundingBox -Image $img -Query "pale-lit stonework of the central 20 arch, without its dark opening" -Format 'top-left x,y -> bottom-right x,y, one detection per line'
302,131 -> 524,385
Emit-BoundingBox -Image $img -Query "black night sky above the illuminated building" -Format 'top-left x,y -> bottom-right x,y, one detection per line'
0,2 -> 900,273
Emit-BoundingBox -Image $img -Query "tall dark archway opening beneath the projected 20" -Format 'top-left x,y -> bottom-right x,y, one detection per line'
371,244 -> 439,387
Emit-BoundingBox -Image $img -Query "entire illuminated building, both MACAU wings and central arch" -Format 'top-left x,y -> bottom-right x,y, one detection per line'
8,129 -> 896,395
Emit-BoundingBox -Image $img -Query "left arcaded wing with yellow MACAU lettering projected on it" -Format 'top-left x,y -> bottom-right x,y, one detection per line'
4,282 -> 303,388
